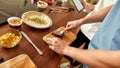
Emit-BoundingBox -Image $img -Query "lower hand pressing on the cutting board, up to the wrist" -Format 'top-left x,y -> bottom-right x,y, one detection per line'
47,38 -> 68,55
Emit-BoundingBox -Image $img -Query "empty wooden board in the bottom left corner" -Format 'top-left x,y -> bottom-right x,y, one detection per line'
0,54 -> 37,68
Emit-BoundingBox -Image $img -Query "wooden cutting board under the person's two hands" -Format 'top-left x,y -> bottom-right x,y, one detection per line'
43,27 -> 76,45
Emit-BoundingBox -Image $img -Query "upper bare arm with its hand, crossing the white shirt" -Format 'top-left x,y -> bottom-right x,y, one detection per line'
66,5 -> 112,30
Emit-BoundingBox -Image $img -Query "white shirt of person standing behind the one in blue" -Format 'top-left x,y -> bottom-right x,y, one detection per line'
81,0 -> 116,40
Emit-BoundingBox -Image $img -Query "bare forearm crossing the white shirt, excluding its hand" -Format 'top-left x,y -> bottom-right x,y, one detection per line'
80,5 -> 112,25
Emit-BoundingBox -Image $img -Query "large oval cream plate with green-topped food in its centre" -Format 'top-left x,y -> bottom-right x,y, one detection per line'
22,11 -> 52,29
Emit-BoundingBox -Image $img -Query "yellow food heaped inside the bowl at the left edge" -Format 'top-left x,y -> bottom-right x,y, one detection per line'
0,33 -> 20,48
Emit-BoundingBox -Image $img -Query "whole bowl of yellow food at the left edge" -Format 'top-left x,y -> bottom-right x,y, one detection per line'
0,28 -> 22,48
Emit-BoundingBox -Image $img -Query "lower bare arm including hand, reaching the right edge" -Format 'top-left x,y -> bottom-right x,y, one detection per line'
48,38 -> 120,68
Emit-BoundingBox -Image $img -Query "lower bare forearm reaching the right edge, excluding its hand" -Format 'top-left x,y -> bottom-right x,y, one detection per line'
64,47 -> 120,68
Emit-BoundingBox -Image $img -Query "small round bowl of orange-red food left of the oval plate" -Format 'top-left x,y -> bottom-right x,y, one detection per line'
7,17 -> 23,28
